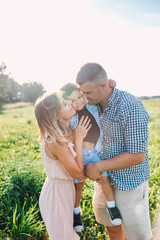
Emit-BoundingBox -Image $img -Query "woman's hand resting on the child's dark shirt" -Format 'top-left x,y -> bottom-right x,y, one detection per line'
75,116 -> 92,141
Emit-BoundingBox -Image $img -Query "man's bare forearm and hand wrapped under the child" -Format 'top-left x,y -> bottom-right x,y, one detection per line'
85,152 -> 145,180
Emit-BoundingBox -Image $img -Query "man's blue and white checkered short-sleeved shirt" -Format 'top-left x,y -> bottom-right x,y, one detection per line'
99,88 -> 150,191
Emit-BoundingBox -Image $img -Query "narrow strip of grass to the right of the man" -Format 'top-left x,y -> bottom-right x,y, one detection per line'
143,99 -> 160,225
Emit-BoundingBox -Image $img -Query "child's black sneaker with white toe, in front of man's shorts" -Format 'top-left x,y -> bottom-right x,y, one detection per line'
106,207 -> 122,225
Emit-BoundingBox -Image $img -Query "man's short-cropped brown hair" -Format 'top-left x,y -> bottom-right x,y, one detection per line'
76,63 -> 108,85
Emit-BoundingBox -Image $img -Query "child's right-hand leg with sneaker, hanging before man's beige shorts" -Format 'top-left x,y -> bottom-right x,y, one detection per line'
101,175 -> 122,225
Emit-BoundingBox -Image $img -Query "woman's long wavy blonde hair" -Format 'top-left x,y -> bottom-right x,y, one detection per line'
35,93 -> 71,145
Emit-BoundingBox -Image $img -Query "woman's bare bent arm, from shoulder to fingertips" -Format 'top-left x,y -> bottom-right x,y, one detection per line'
47,117 -> 91,179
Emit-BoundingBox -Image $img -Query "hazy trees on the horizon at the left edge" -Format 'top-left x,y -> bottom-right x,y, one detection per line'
0,63 -> 46,107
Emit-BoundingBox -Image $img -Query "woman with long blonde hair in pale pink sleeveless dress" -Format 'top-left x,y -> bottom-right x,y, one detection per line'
35,93 -> 91,240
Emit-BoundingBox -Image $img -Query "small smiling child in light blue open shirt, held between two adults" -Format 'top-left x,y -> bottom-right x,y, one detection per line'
61,80 -> 122,232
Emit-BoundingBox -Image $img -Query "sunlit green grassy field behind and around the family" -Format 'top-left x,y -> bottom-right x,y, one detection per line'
0,100 -> 160,240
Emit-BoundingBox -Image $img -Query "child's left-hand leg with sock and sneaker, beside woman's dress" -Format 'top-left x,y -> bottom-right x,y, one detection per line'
73,180 -> 85,232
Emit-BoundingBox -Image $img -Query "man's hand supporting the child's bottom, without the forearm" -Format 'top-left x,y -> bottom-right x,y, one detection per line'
84,163 -> 102,181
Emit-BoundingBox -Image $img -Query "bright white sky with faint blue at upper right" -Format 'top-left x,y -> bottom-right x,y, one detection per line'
0,0 -> 160,96
